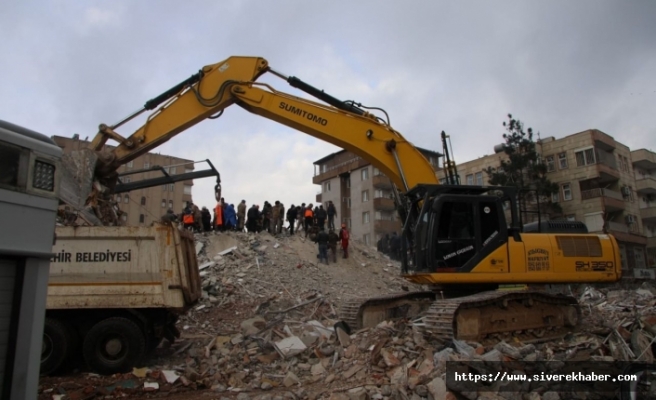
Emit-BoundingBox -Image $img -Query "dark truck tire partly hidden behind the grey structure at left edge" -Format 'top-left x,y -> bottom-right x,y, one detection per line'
40,318 -> 73,375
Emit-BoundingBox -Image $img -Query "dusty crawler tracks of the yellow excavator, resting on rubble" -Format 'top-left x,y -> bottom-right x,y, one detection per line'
340,290 -> 581,342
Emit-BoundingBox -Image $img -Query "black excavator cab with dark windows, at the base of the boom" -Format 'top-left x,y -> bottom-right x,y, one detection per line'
403,185 -> 520,273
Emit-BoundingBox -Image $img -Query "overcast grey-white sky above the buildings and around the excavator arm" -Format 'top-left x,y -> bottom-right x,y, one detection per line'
0,0 -> 656,212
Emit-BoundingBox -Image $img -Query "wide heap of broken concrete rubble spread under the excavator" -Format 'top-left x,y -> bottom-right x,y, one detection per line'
39,233 -> 656,400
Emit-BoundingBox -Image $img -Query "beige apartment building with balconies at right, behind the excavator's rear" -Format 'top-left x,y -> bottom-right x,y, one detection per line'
458,129 -> 656,279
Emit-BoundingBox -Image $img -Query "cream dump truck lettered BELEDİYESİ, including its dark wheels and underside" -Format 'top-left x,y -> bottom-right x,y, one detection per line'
41,222 -> 201,375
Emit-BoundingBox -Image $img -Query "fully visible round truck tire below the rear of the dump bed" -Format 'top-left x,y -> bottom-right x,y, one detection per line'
82,317 -> 146,375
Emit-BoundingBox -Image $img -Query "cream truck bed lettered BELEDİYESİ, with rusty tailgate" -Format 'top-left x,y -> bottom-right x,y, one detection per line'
47,224 -> 201,310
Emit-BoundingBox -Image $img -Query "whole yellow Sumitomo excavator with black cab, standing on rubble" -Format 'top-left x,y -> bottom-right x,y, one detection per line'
64,56 -> 621,340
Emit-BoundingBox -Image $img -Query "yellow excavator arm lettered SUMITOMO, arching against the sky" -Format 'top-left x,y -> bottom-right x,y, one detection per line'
91,57 -> 438,200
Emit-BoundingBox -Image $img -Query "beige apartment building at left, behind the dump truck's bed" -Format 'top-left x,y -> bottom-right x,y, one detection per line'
52,135 -> 195,226
